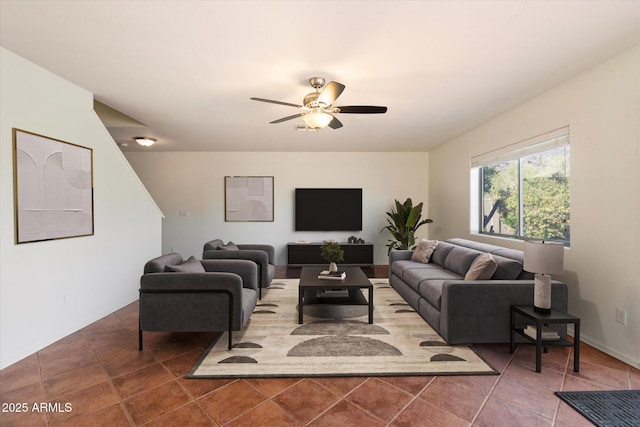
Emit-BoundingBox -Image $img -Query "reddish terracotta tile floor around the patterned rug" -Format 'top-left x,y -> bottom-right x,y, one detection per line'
0,271 -> 640,427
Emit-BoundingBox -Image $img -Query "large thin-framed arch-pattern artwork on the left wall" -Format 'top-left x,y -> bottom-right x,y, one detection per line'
13,128 -> 93,243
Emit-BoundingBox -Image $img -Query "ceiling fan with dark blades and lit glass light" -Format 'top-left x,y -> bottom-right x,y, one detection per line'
251,77 -> 387,129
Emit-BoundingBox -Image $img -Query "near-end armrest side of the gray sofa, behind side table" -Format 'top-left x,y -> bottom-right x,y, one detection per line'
440,280 -> 568,344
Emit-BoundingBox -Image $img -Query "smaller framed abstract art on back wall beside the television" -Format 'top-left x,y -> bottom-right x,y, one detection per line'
224,176 -> 273,222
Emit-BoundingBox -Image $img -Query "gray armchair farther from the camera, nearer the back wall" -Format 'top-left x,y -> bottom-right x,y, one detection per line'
202,239 -> 276,299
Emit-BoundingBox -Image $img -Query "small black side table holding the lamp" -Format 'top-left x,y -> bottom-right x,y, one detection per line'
509,305 -> 580,372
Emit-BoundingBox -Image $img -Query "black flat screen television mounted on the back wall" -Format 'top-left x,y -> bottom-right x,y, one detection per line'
295,188 -> 362,231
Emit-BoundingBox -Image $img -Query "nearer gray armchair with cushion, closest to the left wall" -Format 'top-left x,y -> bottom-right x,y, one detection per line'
138,253 -> 258,351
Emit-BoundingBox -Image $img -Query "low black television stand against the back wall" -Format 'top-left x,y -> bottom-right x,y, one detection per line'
287,242 -> 373,267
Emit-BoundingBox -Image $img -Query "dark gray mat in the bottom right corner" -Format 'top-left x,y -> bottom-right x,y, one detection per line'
556,390 -> 640,427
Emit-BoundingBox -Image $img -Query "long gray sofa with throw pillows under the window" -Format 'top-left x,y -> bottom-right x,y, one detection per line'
389,238 -> 567,344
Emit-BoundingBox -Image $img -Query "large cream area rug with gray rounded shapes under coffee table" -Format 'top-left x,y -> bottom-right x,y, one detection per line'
187,279 -> 497,378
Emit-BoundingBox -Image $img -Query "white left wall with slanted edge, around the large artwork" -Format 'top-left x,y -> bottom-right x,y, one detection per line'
0,48 -> 162,369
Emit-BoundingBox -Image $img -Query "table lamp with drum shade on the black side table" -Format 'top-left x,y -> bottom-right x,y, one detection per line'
524,240 -> 564,313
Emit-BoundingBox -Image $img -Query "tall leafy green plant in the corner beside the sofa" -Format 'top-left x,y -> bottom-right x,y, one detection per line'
380,198 -> 433,253
